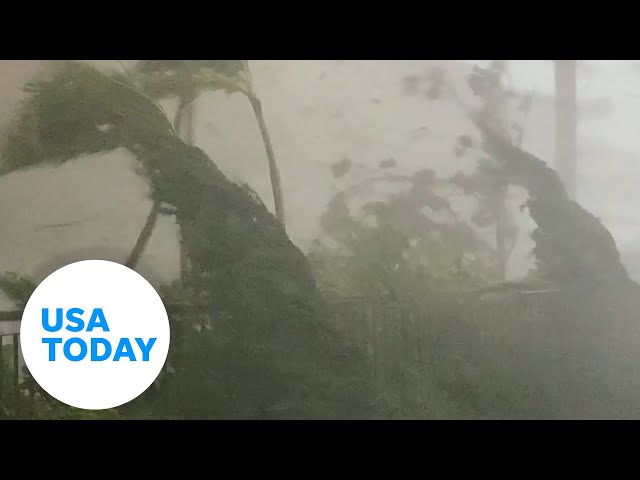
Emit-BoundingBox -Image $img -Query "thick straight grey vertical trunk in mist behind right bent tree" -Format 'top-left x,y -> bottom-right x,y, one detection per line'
554,60 -> 578,199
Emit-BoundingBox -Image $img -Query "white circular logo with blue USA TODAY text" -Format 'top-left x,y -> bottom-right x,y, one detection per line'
20,260 -> 170,410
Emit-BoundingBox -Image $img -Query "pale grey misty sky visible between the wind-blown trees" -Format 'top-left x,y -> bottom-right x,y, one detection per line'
0,60 -> 640,290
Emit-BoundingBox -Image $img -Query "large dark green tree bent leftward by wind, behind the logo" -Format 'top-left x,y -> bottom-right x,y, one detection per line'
0,62 -> 368,418
